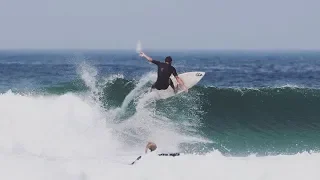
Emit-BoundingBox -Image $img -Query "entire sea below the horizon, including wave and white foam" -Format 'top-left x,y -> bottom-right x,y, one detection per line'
0,52 -> 320,180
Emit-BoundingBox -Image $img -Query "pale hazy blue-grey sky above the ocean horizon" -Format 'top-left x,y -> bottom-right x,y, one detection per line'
0,0 -> 320,49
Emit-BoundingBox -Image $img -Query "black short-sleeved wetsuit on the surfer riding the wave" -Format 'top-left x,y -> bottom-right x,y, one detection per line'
151,60 -> 178,90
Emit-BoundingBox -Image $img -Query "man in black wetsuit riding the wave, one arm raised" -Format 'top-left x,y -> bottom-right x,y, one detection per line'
140,52 -> 188,93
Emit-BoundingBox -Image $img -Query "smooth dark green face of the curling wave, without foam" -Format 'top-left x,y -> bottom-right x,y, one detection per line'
42,77 -> 320,155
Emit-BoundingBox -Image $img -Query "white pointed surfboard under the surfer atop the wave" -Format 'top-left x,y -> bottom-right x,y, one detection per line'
152,72 -> 205,99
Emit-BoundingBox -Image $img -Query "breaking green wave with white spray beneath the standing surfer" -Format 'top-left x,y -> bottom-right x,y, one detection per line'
10,71 -> 320,155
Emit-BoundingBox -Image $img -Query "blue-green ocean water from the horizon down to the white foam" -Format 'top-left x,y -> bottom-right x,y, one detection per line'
0,51 -> 320,156
